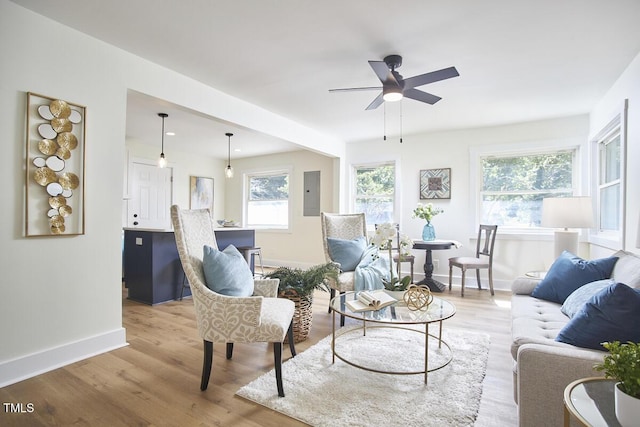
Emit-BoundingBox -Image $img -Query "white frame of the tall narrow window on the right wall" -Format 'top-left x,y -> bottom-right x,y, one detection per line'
589,99 -> 628,250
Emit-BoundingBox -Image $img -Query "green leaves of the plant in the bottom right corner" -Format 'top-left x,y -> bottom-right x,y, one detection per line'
594,341 -> 640,399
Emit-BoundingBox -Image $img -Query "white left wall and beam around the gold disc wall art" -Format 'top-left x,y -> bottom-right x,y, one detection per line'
0,0 -> 344,386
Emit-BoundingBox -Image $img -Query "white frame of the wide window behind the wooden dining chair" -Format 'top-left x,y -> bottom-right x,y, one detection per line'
469,138 -> 588,240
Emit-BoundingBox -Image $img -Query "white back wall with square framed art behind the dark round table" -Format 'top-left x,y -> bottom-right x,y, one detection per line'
346,116 -> 589,289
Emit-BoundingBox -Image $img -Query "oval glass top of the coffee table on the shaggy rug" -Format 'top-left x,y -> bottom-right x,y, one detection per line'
331,292 -> 456,325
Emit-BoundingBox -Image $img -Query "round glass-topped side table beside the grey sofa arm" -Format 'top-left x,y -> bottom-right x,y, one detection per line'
564,378 -> 620,427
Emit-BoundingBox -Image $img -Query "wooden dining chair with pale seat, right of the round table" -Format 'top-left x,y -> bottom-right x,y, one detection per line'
449,224 -> 498,296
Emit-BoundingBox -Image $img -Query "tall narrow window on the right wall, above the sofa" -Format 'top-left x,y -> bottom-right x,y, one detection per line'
589,101 -> 627,249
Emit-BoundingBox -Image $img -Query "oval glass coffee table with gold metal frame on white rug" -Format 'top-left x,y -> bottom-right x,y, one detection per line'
330,292 -> 456,384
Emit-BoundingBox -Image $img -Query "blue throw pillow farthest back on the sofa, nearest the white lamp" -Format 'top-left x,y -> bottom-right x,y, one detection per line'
531,251 -> 618,304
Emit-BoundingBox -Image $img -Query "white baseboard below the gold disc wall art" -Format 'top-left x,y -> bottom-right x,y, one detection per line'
0,328 -> 129,388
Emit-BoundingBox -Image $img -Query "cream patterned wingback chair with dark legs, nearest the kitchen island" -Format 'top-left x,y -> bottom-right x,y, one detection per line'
171,205 -> 296,397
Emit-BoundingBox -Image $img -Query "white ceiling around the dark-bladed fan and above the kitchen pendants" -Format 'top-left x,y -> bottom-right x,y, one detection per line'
8,0 -> 640,158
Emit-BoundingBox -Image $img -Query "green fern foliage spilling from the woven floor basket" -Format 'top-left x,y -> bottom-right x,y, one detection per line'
265,263 -> 340,296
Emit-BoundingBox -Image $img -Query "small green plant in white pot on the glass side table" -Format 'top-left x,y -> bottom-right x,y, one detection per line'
595,341 -> 640,427
